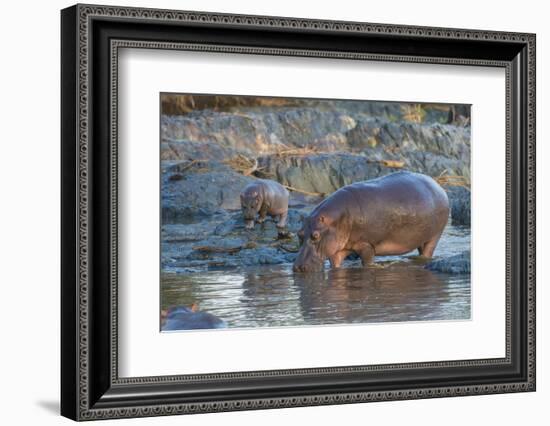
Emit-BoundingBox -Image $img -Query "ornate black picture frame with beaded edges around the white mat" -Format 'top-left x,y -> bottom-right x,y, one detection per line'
61,5 -> 536,420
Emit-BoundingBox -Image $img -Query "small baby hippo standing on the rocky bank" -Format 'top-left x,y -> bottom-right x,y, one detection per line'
241,179 -> 288,229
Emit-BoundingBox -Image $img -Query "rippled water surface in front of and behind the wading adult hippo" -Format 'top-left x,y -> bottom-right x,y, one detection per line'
161,225 -> 471,328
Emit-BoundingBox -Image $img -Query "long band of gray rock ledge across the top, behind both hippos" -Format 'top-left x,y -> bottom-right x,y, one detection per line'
161,107 -> 470,181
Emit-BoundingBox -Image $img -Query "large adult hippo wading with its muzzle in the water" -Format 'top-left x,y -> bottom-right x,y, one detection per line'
293,172 -> 449,272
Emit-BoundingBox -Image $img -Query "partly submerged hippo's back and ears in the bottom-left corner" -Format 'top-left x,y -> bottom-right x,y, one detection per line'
161,304 -> 227,331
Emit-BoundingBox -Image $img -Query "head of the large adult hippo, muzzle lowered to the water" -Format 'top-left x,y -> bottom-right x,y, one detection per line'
292,214 -> 341,272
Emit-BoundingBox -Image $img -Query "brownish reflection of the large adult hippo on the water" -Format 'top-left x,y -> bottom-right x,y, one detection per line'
293,261 -> 460,324
